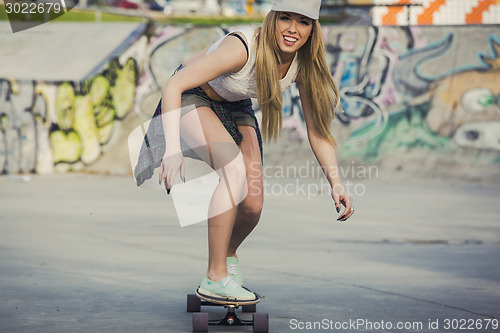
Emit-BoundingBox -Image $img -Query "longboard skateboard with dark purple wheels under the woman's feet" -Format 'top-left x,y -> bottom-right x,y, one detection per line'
187,289 -> 269,333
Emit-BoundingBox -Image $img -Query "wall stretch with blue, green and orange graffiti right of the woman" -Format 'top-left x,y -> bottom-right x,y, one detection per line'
320,26 -> 500,161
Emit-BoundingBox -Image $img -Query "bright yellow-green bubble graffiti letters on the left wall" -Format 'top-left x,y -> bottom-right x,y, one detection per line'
49,58 -> 138,169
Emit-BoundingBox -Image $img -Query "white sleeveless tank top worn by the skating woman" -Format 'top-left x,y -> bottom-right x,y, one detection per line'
207,27 -> 299,102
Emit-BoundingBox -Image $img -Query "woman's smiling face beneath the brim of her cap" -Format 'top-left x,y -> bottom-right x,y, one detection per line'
276,12 -> 313,54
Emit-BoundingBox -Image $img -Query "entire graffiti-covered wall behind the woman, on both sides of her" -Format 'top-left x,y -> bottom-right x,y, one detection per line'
0,25 -> 500,179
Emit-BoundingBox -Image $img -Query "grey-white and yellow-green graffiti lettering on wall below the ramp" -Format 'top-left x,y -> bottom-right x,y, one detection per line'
0,58 -> 138,174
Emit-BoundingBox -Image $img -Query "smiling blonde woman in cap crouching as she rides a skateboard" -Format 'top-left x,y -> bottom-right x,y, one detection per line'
160,0 -> 354,301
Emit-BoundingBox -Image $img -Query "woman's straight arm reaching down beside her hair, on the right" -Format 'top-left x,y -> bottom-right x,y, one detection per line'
297,77 -> 354,221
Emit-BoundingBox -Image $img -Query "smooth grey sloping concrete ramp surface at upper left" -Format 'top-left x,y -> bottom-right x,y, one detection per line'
0,21 -> 145,81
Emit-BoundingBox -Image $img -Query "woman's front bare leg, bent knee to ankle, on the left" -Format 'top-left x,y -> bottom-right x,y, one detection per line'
181,107 -> 247,281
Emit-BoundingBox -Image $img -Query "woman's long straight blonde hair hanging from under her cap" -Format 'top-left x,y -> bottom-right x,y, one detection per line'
255,11 -> 339,145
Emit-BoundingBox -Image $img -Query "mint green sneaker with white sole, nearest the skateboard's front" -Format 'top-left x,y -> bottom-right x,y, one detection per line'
197,276 -> 256,301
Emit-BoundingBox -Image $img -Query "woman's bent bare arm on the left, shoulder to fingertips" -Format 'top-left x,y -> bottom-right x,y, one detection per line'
160,37 -> 247,189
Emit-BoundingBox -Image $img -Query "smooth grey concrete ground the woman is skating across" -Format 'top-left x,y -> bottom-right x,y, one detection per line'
0,174 -> 500,333
